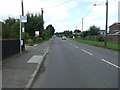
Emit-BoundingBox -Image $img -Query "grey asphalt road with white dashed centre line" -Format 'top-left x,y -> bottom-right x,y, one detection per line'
32,38 -> 119,88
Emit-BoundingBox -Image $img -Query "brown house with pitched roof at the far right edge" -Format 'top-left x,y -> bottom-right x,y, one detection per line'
109,22 -> 120,35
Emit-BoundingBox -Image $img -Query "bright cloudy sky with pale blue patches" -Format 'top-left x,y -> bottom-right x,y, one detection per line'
0,0 -> 120,32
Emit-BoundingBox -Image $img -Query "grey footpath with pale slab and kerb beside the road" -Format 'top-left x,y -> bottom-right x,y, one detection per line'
2,40 -> 51,88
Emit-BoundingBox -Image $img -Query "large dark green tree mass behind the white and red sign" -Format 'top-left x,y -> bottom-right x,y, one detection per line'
25,13 -> 44,38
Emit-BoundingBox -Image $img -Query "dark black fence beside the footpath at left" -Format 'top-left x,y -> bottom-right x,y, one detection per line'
2,39 -> 24,60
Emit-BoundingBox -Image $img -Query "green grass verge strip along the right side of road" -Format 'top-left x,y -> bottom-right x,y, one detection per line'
71,39 -> 120,51
